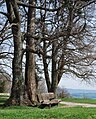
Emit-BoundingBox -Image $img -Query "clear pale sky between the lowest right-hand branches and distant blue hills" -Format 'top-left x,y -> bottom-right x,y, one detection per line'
59,76 -> 96,90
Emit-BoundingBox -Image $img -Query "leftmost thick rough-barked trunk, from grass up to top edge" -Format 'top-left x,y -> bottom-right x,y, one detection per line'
6,0 -> 23,105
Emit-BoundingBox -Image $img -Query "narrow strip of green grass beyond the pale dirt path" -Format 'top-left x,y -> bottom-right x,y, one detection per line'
61,98 -> 96,104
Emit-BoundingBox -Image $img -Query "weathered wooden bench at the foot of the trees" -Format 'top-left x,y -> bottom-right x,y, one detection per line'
38,93 -> 60,108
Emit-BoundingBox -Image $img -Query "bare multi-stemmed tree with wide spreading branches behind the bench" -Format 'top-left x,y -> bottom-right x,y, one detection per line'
36,0 -> 95,93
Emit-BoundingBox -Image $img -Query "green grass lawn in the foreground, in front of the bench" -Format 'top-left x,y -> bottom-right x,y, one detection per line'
0,96 -> 96,119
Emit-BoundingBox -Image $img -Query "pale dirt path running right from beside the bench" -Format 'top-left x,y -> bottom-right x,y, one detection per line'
60,101 -> 96,107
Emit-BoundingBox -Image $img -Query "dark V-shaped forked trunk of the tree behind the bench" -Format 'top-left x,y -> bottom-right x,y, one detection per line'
43,41 -> 60,96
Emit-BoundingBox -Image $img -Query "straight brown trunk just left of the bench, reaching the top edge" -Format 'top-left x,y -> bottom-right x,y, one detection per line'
25,0 -> 37,105
